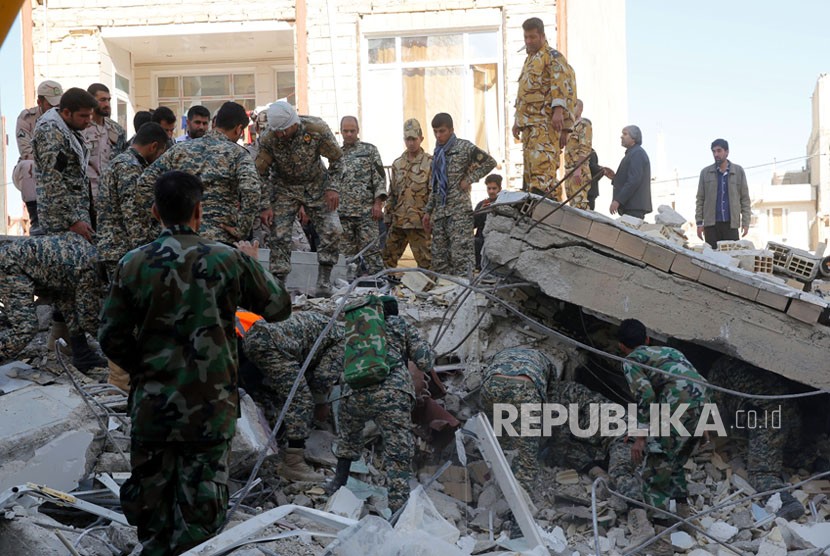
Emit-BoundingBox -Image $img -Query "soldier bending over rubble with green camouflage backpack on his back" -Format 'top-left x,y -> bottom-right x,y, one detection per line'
326,296 -> 435,512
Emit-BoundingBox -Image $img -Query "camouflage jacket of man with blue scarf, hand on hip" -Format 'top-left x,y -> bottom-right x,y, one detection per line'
424,139 -> 496,215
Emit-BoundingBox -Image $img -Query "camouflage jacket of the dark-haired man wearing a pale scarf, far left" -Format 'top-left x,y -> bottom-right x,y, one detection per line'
32,108 -> 94,234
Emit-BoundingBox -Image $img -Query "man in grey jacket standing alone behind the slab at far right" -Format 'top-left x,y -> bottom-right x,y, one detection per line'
695,139 -> 752,249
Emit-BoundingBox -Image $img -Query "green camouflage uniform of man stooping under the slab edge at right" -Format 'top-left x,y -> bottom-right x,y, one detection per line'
623,346 -> 709,508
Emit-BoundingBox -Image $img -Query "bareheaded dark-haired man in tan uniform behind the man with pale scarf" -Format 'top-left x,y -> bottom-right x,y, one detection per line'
81,83 -> 127,200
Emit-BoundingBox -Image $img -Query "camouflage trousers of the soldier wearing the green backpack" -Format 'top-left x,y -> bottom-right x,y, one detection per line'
335,384 -> 415,512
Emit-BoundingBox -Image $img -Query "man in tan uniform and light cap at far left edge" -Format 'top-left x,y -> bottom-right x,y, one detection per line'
12,80 -> 63,236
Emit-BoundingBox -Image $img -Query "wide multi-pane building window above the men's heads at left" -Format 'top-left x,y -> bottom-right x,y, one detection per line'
156,73 -> 256,136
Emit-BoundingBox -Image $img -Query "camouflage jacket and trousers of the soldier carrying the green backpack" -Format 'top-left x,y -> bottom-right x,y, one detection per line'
335,316 -> 435,512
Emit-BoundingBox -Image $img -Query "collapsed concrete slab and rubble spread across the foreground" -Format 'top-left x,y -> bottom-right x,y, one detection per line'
0,192 -> 830,556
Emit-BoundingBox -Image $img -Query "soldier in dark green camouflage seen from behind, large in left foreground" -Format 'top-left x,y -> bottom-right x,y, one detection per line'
98,172 -> 291,556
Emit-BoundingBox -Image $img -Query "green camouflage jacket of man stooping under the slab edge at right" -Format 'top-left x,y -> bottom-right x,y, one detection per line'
623,346 -> 709,423
